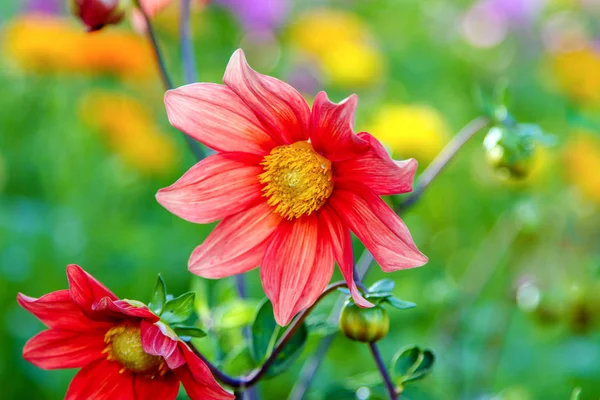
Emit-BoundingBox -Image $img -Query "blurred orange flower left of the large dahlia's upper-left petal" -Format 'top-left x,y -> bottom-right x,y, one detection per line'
81,91 -> 177,174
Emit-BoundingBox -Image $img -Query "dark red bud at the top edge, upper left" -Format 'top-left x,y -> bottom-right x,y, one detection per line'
70,0 -> 127,32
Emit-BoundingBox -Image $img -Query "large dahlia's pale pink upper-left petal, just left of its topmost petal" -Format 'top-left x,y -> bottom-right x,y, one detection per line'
165,83 -> 277,156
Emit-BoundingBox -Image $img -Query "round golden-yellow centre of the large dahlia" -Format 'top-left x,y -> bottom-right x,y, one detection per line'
258,142 -> 333,219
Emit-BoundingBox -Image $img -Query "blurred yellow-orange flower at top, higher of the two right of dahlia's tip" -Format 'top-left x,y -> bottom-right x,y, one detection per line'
290,9 -> 383,86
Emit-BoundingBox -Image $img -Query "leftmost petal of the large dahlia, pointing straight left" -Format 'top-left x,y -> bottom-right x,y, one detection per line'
156,153 -> 263,224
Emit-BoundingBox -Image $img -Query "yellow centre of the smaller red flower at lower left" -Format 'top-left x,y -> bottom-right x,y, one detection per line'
104,324 -> 168,377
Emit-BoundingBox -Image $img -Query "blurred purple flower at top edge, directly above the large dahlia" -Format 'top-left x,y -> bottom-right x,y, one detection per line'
215,0 -> 290,31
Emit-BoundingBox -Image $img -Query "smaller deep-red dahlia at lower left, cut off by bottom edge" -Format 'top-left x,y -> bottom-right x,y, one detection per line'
17,265 -> 233,400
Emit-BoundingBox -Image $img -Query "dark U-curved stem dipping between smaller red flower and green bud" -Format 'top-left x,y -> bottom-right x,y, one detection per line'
188,281 -> 347,392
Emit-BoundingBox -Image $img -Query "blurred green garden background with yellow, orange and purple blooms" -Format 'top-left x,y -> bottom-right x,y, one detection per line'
0,0 -> 600,400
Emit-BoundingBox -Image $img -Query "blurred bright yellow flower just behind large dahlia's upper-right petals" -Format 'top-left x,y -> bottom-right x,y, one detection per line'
367,104 -> 450,165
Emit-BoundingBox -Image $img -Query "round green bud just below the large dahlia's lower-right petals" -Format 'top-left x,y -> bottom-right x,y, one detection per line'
340,300 -> 390,343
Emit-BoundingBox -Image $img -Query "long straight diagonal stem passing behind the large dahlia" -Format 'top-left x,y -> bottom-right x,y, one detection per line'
288,116 -> 490,400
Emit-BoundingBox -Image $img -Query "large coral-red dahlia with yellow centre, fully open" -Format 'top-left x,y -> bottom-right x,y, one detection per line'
156,50 -> 427,325
